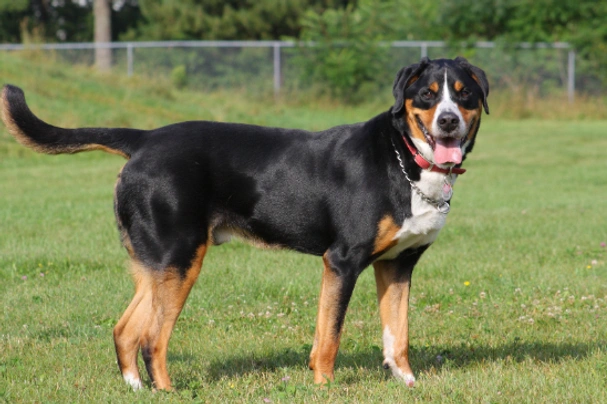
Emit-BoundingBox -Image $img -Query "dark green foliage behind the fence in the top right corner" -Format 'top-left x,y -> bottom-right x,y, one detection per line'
439,0 -> 607,83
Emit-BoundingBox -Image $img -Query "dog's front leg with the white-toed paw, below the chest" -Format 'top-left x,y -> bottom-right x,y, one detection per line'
373,250 -> 423,387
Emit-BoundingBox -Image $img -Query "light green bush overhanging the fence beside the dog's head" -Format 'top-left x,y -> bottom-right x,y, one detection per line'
297,0 -> 442,102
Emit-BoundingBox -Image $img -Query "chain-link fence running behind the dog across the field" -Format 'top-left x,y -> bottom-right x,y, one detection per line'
0,41 -> 604,102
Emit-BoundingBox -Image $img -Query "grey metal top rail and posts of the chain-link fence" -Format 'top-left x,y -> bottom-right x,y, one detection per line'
0,41 -> 592,102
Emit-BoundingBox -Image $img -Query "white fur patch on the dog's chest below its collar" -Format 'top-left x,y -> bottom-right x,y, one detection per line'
378,170 -> 447,259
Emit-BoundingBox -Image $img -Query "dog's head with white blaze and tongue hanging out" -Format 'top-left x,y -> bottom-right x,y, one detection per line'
392,57 -> 489,168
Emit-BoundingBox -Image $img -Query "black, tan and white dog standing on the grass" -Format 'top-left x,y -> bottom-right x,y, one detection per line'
2,58 -> 489,389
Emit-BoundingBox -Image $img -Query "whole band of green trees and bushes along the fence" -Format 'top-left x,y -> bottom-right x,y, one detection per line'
0,0 -> 607,89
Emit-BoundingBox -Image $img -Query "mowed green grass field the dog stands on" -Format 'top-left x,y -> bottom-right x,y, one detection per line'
0,55 -> 607,403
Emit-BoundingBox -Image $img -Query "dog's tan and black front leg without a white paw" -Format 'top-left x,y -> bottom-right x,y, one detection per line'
309,252 -> 360,384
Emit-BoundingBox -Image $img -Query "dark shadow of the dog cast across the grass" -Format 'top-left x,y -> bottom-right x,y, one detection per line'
171,340 -> 607,383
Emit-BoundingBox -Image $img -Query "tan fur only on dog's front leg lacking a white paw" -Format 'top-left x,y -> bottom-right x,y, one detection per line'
309,254 -> 341,384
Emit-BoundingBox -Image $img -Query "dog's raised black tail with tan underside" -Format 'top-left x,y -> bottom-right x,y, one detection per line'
0,85 -> 146,159
